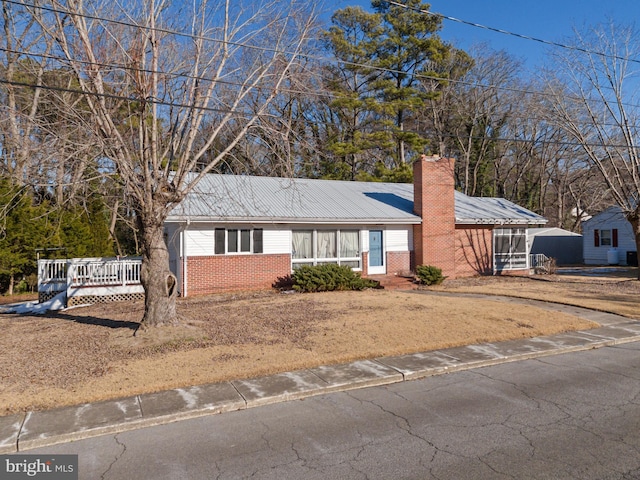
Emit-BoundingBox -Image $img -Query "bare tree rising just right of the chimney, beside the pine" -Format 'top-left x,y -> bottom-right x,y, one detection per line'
422,45 -> 521,196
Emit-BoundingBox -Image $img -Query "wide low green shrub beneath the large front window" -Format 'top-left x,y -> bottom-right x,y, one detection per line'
292,264 -> 378,292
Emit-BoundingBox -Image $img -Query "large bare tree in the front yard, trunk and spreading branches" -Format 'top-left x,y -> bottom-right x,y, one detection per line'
25,0 -> 315,328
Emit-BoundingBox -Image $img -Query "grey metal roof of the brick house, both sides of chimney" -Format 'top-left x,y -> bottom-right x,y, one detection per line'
167,174 -> 546,224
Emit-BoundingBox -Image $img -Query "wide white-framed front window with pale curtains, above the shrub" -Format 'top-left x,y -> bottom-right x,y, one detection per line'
291,230 -> 361,269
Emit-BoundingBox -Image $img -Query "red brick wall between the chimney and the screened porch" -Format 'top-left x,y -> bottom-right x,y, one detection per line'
456,225 -> 493,277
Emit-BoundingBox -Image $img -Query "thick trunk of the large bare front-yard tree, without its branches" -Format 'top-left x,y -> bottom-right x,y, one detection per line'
140,219 -> 178,330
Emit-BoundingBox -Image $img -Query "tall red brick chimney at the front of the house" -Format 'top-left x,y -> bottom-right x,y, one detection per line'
413,155 -> 456,278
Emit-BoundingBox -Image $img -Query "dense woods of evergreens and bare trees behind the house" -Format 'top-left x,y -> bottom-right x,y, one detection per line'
0,0 -> 620,291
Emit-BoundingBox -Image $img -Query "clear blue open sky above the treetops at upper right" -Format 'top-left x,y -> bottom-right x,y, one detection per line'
326,0 -> 640,69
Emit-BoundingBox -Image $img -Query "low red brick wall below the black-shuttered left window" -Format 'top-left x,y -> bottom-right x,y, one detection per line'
187,254 -> 291,296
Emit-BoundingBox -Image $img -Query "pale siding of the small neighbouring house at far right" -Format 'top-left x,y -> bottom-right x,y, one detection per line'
582,207 -> 636,265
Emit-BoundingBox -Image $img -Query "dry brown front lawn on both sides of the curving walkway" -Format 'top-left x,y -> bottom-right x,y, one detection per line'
0,276 -> 640,415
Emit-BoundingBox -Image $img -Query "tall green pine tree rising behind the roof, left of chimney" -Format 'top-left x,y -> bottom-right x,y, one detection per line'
325,0 -> 455,179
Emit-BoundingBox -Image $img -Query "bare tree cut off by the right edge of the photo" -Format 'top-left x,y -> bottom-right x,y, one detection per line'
549,23 -> 640,279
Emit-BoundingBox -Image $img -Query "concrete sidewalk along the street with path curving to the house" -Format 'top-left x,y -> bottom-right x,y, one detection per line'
0,291 -> 640,454
